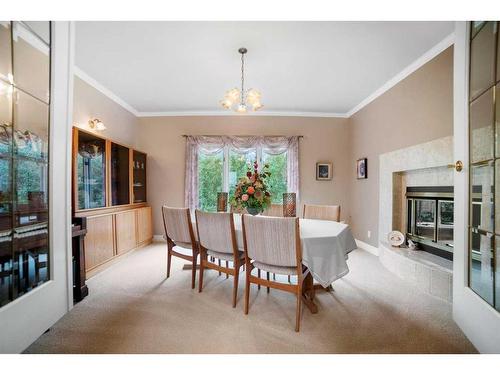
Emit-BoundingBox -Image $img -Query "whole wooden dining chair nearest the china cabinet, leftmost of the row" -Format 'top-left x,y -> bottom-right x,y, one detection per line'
161,206 -> 199,289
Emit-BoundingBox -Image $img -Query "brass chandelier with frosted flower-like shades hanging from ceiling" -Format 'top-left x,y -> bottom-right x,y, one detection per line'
220,47 -> 263,113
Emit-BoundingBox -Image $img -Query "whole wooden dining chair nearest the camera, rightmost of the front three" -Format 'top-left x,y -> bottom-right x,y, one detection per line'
242,215 -> 309,332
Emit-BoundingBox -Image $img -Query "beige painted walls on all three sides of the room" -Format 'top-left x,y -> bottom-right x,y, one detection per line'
74,48 -> 453,246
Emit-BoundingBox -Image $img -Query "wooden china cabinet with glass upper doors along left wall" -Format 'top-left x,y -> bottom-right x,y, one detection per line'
72,127 -> 153,278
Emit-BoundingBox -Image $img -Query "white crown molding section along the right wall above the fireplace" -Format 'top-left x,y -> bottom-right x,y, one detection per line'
346,33 -> 455,117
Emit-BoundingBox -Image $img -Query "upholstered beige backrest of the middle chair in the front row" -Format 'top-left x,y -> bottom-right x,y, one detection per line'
196,210 -> 234,254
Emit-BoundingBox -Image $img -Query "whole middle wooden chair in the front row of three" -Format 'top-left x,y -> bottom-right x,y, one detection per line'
195,210 -> 245,307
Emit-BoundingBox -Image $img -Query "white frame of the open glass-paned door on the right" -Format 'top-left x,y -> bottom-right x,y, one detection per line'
453,21 -> 500,353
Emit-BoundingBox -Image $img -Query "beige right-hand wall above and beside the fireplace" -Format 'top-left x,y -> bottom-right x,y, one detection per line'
349,47 -> 453,246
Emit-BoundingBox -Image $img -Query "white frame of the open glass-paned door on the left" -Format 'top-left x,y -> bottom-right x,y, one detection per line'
0,21 -> 74,353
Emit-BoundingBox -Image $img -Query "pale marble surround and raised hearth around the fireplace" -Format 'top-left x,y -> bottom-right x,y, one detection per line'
379,136 -> 453,302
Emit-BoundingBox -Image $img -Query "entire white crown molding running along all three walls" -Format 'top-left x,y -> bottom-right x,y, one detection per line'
74,33 -> 455,118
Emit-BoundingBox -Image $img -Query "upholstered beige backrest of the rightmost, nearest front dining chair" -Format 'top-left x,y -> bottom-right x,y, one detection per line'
243,215 -> 301,267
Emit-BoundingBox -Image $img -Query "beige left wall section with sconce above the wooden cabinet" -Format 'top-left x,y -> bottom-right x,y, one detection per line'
73,76 -> 139,147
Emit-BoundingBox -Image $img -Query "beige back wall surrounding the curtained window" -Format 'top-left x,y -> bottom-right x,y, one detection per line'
137,116 -> 351,234
